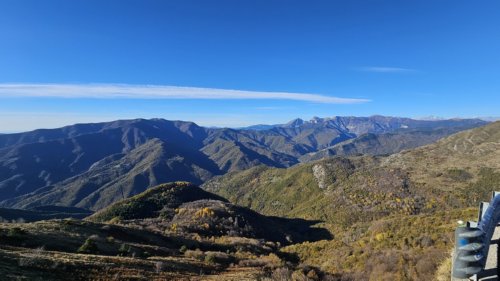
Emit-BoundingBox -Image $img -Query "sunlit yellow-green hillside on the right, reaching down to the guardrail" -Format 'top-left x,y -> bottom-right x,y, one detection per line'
204,122 -> 500,280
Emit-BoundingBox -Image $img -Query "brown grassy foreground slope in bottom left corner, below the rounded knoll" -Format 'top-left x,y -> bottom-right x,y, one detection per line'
0,220 -> 214,280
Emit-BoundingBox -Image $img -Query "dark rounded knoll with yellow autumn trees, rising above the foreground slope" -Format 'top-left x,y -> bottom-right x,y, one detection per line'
88,182 -> 331,244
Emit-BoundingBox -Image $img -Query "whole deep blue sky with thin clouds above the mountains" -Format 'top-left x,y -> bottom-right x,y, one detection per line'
0,0 -> 500,132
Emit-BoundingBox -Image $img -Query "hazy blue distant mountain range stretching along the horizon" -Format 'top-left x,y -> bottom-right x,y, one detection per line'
0,116 -> 487,210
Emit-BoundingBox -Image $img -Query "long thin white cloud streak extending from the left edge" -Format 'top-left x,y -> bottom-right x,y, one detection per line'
0,84 -> 370,104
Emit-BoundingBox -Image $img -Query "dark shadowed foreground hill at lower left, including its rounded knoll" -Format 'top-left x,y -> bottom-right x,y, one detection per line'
0,182 -> 332,281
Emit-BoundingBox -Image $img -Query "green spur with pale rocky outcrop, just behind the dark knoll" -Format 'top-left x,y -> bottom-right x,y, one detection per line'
204,157 -> 434,226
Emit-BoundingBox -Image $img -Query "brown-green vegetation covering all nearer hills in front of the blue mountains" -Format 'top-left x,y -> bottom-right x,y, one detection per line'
0,121 -> 500,281
